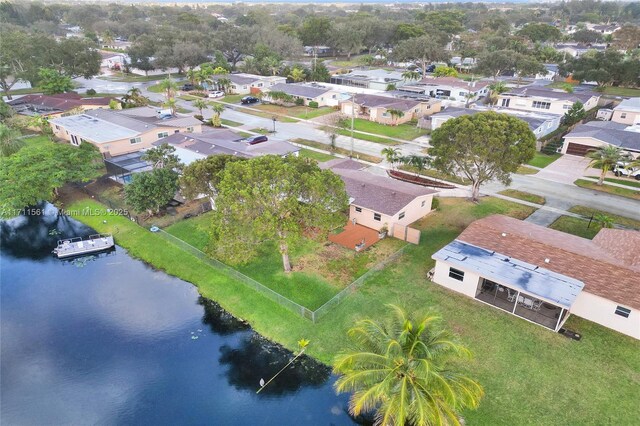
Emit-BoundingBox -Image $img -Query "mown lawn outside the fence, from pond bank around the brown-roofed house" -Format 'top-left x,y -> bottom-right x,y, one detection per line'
67,198 -> 640,425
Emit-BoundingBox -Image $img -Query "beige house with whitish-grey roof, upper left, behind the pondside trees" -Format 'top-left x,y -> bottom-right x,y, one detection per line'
49,107 -> 202,157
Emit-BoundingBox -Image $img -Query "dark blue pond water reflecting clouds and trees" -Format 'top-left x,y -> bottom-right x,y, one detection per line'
0,208 -> 353,425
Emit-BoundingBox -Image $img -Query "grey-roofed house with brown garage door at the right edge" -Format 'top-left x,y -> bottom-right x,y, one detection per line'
562,121 -> 640,157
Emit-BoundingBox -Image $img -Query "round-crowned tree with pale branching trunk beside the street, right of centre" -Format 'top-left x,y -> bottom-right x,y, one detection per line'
429,111 -> 536,201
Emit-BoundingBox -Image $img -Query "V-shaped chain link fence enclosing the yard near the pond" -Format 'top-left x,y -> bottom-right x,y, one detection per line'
156,229 -> 409,323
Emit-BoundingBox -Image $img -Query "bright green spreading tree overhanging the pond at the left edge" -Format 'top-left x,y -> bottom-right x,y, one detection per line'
0,143 -> 103,217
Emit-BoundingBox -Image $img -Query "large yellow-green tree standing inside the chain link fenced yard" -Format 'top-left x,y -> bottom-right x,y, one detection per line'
212,155 -> 348,272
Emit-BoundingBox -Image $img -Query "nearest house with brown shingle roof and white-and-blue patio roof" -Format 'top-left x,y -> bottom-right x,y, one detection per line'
432,215 -> 640,339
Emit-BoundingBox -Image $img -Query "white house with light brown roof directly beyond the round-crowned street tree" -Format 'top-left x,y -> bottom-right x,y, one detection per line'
398,77 -> 489,102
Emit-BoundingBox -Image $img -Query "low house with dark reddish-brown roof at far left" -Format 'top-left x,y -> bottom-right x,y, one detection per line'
7,93 -> 113,118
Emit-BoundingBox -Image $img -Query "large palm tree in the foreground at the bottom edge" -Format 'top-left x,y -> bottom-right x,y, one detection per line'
333,305 -> 484,426
